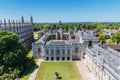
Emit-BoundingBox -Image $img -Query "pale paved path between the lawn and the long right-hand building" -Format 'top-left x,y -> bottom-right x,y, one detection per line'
75,61 -> 89,80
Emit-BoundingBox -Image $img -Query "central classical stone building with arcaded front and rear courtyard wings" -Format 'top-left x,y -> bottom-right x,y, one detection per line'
32,29 -> 83,61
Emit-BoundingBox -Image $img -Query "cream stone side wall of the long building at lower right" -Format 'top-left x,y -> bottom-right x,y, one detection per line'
85,49 -> 119,80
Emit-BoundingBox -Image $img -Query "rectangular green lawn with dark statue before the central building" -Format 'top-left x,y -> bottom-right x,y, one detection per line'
35,62 -> 82,80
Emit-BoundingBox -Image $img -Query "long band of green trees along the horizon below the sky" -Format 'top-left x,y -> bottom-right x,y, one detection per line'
34,22 -> 120,32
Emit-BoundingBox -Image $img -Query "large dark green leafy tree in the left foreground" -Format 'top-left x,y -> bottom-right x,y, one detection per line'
0,31 -> 29,80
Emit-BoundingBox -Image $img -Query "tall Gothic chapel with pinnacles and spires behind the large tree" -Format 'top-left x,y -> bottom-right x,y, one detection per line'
0,16 -> 33,47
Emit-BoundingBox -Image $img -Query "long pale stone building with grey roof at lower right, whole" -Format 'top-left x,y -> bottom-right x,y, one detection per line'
85,45 -> 120,80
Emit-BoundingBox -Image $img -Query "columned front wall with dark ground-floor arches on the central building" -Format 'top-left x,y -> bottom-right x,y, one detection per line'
44,46 -> 72,61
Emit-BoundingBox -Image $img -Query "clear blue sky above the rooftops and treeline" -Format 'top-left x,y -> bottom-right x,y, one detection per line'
0,0 -> 120,23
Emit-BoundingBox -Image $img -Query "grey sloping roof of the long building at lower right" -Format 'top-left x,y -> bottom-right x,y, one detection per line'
89,45 -> 120,73
